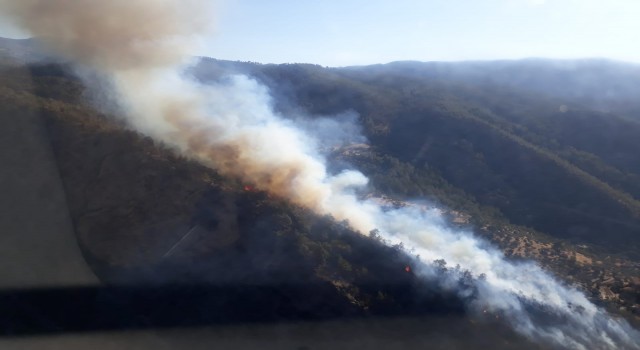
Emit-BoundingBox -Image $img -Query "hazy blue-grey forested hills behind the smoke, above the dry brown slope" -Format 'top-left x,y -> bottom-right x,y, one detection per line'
196,60 -> 640,258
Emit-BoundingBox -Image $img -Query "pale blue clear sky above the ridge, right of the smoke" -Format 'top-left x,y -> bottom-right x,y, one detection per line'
0,0 -> 640,66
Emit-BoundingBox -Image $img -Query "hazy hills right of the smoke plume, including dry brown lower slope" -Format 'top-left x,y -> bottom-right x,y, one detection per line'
194,59 -> 640,321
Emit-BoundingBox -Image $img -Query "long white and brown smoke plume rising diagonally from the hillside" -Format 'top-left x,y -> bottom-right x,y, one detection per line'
0,0 -> 640,349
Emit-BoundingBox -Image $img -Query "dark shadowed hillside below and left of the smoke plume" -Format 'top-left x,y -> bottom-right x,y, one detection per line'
43,102 -> 460,314
